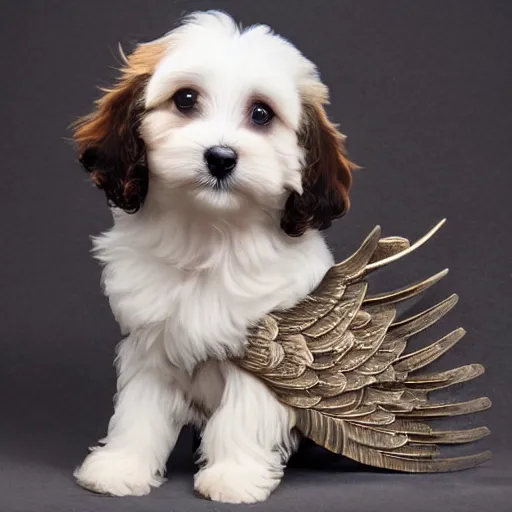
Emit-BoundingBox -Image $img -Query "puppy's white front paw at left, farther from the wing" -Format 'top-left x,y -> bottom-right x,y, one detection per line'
74,447 -> 164,496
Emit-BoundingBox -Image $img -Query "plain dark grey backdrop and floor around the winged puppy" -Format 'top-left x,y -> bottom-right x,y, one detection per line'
0,0 -> 512,512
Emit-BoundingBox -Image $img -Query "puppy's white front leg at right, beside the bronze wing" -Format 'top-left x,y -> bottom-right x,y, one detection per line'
194,362 -> 297,503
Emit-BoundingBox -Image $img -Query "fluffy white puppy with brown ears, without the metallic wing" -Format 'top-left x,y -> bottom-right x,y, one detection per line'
74,12 -> 353,503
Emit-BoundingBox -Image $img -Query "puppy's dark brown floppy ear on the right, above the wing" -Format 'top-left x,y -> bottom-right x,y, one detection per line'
281,103 -> 357,236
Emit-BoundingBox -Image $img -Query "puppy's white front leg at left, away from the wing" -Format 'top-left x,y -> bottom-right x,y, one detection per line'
74,339 -> 188,496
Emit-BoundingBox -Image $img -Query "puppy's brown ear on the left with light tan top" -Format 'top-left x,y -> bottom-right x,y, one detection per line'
73,44 -> 163,213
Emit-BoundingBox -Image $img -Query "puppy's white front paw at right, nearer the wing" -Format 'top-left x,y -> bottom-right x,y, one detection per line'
194,463 -> 282,503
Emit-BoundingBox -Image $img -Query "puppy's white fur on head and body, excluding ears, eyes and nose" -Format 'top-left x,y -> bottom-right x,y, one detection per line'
75,13 -> 332,503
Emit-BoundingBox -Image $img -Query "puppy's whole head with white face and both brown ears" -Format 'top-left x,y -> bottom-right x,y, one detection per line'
75,12 -> 353,236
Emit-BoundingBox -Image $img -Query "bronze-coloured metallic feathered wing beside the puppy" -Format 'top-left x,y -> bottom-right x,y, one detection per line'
238,221 -> 491,472
